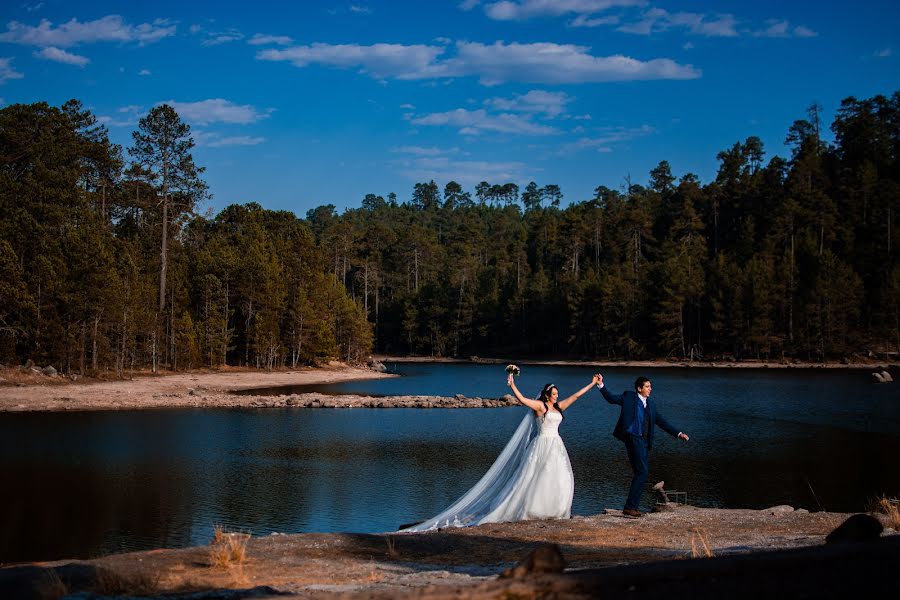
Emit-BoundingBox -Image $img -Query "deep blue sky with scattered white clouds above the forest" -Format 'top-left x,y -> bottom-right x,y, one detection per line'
0,0 -> 900,216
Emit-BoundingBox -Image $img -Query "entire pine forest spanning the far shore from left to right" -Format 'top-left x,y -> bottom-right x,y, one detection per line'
0,92 -> 900,371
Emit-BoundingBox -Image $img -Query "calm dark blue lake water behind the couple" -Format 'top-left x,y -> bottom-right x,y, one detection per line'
0,363 -> 900,562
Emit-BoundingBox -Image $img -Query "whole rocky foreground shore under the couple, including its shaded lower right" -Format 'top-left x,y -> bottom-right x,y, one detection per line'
0,506 -> 900,600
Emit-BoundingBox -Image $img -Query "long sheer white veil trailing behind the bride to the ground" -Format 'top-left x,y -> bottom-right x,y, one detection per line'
401,410 -> 537,532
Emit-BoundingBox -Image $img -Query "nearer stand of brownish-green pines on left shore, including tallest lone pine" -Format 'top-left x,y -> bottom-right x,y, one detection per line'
0,101 -> 372,374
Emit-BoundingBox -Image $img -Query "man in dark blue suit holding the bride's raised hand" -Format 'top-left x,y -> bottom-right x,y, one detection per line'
597,373 -> 690,518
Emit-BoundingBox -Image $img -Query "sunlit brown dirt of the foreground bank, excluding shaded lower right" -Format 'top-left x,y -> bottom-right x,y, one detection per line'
0,506 -> 900,598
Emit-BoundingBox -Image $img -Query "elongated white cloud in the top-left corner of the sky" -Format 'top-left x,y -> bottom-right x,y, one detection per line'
0,15 -> 176,48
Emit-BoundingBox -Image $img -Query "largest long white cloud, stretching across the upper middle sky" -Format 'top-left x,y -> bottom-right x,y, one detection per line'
256,42 -> 700,85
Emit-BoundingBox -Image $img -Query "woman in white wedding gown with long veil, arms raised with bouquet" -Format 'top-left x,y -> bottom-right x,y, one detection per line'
401,365 -> 599,532
